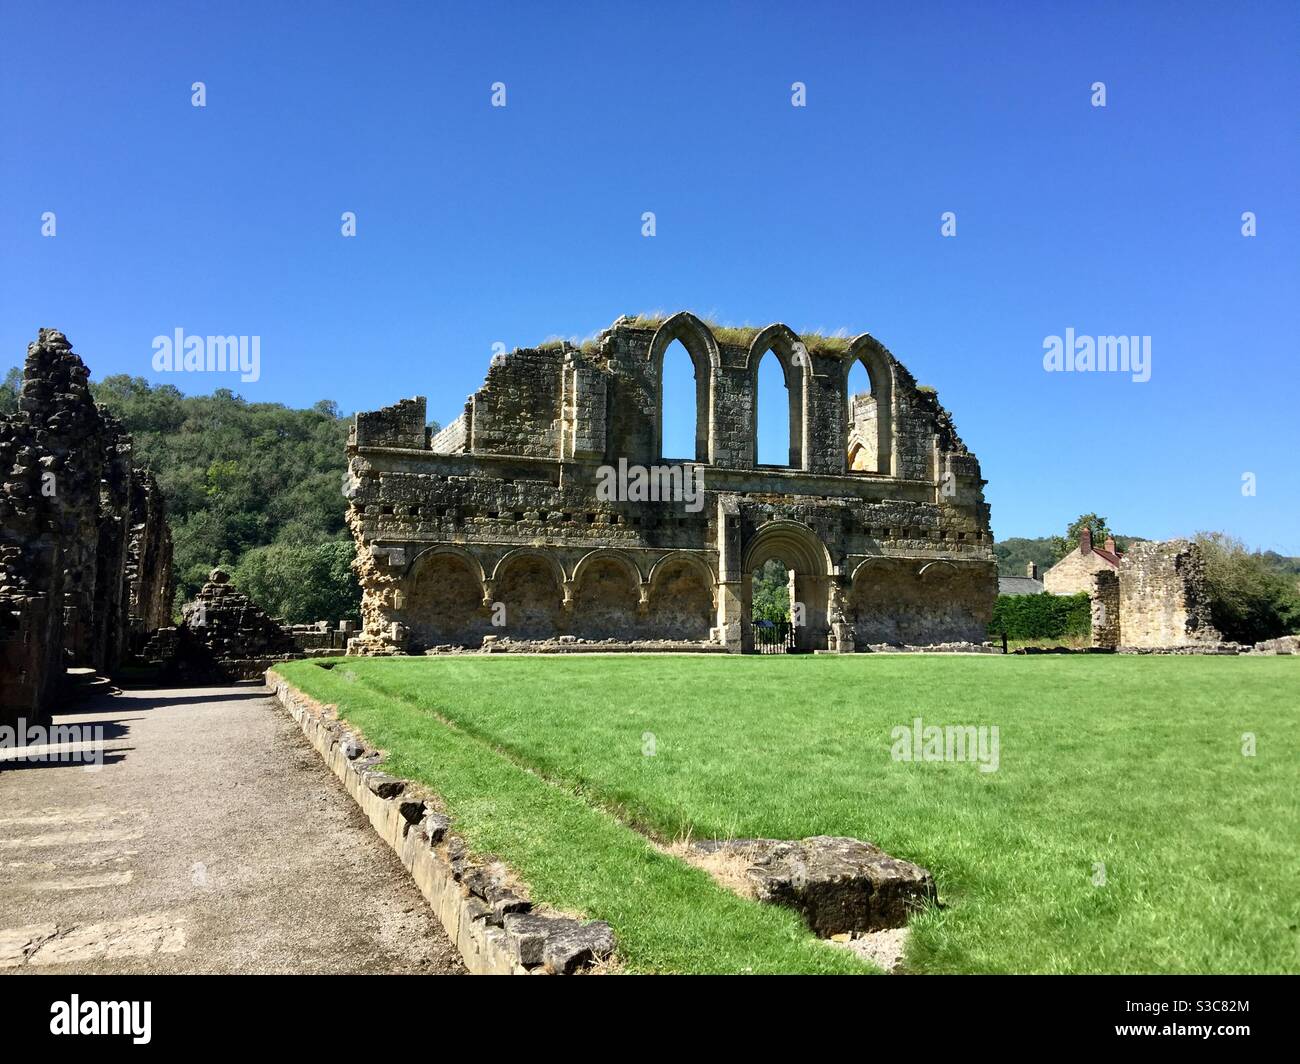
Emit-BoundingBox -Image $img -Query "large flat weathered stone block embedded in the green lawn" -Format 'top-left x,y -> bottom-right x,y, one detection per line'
696,835 -> 936,938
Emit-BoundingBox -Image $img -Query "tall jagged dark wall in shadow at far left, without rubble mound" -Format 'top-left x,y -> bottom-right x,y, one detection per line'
0,329 -> 172,722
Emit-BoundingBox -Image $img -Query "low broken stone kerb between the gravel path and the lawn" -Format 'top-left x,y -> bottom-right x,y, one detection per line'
267,669 -> 614,976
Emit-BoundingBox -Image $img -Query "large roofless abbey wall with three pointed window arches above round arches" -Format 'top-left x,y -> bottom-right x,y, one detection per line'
347,312 -> 997,654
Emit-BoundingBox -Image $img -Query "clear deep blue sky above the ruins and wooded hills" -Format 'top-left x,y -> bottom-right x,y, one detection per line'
0,0 -> 1300,554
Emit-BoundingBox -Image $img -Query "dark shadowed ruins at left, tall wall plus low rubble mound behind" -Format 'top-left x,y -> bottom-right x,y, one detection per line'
0,329 -> 366,726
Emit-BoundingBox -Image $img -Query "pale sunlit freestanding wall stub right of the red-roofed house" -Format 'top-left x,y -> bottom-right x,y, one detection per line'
1119,540 -> 1221,646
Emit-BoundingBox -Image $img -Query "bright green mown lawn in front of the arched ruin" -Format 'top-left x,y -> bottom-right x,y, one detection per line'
281,654 -> 1300,973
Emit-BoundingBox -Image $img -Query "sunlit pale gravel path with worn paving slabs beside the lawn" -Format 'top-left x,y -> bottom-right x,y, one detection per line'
0,684 -> 464,974
